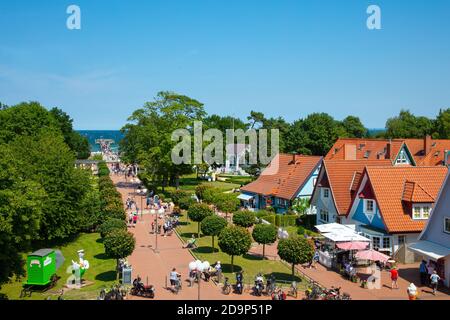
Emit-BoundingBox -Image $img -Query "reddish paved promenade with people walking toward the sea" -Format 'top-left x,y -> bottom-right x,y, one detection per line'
111,175 -> 276,300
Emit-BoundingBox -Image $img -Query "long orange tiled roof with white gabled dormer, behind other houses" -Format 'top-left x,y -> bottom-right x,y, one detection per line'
324,136 -> 450,166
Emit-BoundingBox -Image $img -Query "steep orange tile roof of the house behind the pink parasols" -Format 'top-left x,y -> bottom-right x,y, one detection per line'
365,166 -> 448,233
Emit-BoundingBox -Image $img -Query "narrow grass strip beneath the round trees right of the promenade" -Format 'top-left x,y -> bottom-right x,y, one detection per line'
177,214 -> 306,290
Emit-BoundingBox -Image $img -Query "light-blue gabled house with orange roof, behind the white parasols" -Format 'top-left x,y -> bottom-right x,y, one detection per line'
311,159 -> 392,224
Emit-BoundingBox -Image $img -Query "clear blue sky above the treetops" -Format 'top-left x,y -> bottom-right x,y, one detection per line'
0,0 -> 450,129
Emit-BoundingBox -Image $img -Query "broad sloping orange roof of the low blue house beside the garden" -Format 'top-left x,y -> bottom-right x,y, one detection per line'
241,154 -> 322,200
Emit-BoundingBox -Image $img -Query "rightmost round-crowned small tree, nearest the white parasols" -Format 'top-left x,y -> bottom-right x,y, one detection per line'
278,237 -> 315,278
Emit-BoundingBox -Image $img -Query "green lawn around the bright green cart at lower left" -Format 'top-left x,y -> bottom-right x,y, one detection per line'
0,233 -> 116,300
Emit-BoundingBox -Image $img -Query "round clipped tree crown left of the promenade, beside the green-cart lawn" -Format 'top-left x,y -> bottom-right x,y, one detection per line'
103,229 -> 136,259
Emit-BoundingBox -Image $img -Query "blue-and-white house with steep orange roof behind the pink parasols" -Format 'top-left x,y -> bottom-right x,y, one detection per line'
345,166 -> 448,263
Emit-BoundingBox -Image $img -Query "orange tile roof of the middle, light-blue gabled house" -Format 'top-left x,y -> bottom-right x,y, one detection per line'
322,160 -> 392,216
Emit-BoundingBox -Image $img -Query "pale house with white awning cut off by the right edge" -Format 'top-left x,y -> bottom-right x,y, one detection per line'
409,174 -> 450,287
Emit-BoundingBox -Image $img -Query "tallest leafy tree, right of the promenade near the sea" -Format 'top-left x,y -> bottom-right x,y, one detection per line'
120,91 -> 205,192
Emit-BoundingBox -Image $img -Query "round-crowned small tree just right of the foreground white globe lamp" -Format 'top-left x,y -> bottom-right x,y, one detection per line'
219,226 -> 252,272
